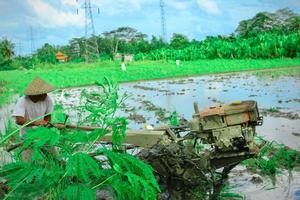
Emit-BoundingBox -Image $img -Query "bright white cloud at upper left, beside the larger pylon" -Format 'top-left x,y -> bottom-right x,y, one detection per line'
27,0 -> 84,28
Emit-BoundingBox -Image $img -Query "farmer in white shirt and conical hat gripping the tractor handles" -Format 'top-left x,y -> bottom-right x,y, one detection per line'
13,77 -> 54,135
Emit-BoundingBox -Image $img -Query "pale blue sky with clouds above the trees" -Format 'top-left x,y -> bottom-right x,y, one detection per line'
0,0 -> 300,55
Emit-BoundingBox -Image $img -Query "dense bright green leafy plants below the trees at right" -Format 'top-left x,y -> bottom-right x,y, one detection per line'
141,31 -> 300,60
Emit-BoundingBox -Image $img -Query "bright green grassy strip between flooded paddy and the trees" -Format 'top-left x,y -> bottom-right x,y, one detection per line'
0,58 -> 300,106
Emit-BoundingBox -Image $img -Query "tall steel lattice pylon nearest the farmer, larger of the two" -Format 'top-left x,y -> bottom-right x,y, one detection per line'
77,0 -> 99,62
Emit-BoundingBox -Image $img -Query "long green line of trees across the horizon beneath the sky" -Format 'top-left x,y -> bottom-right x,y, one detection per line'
0,8 -> 300,70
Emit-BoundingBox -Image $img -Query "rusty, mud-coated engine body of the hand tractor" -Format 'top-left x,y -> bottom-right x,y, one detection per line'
189,100 -> 262,152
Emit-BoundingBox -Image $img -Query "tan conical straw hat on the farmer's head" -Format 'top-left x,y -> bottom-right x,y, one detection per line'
24,77 -> 55,95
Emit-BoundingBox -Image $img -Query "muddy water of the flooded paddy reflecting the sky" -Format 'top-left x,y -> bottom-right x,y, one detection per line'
0,68 -> 300,200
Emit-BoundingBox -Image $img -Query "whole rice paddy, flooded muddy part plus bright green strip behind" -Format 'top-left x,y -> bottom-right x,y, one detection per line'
0,59 -> 300,200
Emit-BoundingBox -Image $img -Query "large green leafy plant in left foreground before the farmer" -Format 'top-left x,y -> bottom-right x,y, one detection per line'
0,79 -> 160,200
